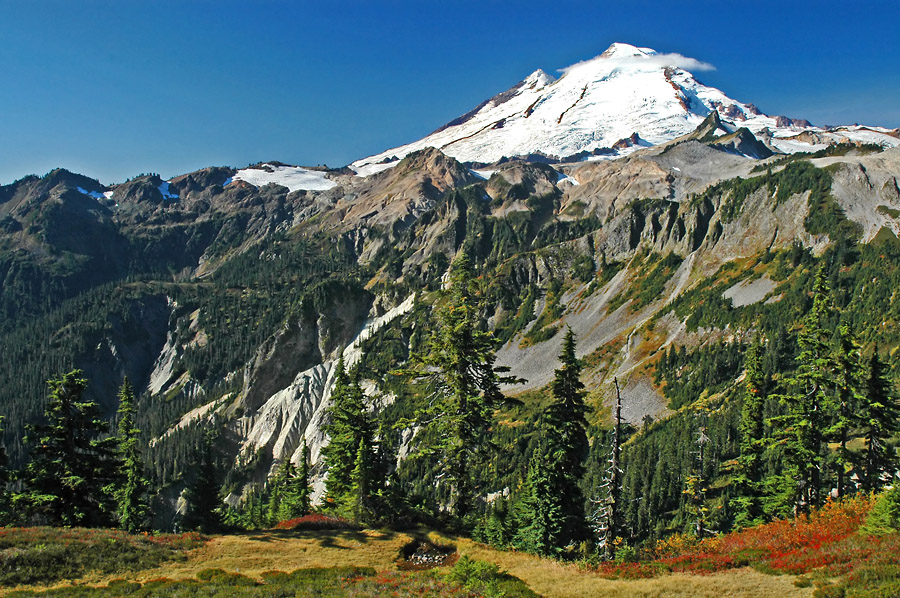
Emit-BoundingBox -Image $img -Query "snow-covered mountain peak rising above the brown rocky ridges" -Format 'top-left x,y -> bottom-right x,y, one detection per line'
353,43 -> 900,172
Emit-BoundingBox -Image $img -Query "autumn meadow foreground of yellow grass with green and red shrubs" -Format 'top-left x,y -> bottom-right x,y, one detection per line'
0,497 -> 900,598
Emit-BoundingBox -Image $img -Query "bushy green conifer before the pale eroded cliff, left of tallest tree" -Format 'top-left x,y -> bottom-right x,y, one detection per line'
322,358 -> 374,504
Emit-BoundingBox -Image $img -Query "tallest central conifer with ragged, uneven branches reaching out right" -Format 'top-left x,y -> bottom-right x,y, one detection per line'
416,253 -> 517,520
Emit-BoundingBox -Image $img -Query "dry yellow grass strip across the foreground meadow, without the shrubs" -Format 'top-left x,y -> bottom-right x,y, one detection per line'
0,530 -> 813,598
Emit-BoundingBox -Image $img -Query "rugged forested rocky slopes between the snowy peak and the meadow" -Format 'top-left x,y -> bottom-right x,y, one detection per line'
0,130 -> 900,556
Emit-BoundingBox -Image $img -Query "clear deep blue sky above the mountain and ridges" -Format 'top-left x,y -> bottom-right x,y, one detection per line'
0,0 -> 900,184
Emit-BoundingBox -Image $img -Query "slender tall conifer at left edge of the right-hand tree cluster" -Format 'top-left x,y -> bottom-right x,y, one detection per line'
731,338 -> 771,528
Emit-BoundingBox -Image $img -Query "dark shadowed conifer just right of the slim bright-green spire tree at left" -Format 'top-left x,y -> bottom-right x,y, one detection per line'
182,430 -> 222,533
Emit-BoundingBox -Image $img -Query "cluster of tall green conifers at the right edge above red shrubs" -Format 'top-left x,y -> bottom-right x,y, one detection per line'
733,269 -> 900,527
